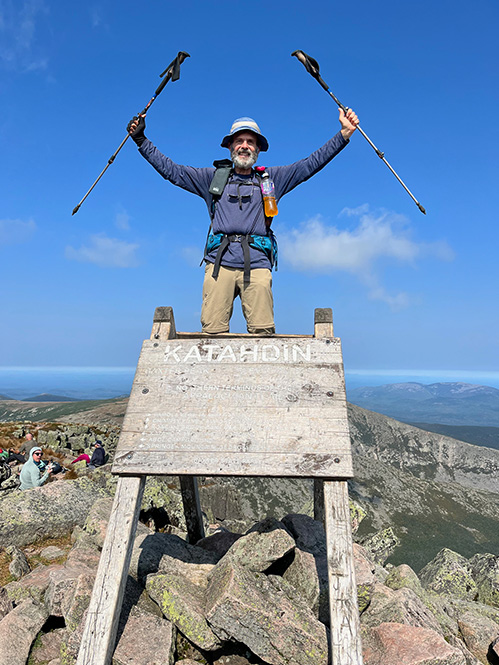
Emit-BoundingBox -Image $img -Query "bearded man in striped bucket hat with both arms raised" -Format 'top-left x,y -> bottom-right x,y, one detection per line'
127,109 -> 359,335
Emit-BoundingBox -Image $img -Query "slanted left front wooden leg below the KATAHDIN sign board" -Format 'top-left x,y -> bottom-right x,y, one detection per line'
77,476 -> 145,665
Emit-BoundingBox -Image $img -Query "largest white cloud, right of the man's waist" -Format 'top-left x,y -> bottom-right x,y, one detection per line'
279,204 -> 454,309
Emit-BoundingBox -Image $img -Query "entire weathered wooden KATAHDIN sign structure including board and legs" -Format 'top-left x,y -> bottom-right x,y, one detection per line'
77,307 -> 362,665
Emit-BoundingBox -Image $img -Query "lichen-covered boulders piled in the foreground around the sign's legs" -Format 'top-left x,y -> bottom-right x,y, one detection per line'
0,481 -> 499,665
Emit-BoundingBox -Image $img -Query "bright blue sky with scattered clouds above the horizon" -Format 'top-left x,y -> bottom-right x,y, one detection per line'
0,0 -> 499,380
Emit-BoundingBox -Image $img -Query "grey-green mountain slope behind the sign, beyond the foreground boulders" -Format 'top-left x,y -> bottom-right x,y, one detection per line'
1,399 -> 499,571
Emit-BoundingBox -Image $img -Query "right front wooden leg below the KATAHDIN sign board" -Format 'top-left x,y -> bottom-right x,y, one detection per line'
324,480 -> 363,665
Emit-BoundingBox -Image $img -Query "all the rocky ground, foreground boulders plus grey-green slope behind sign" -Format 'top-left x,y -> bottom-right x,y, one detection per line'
0,400 -> 499,665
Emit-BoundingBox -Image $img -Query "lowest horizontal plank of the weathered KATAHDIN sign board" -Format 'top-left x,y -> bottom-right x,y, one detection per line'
113,449 -> 353,478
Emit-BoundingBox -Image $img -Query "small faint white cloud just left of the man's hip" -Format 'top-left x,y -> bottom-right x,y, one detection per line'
65,233 -> 139,268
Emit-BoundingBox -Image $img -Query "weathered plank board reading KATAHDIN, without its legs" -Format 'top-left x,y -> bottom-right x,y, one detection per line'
113,336 -> 353,478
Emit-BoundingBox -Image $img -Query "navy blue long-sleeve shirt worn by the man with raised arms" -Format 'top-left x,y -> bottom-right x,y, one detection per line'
139,132 -> 348,269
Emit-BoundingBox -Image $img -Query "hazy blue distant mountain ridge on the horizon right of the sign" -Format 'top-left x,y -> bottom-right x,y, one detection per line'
348,383 -> 499,427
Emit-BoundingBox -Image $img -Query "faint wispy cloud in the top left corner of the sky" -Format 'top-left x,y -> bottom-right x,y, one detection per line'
0,0 -> 48,71
